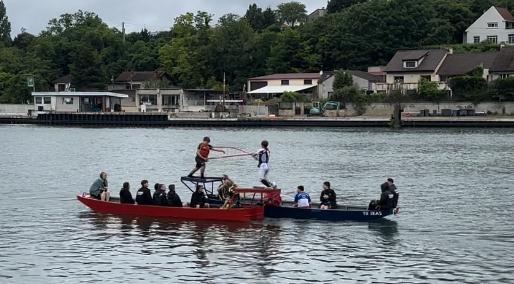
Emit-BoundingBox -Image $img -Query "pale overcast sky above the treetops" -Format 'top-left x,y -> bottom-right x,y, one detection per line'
3,0 -> 327,36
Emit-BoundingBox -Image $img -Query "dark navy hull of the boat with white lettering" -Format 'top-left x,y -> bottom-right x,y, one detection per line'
264,206 -> 393,221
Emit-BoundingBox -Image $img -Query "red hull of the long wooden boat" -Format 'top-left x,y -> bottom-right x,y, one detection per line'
77,195 -> 264,221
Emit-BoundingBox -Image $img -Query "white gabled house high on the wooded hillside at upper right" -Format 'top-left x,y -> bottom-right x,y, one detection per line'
464,6 -> 514,44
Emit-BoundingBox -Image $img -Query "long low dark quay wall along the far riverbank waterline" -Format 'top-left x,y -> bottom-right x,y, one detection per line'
0,114 -> 514,128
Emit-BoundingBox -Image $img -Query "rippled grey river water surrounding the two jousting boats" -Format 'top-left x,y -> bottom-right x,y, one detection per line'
0,126 -> 514,283
